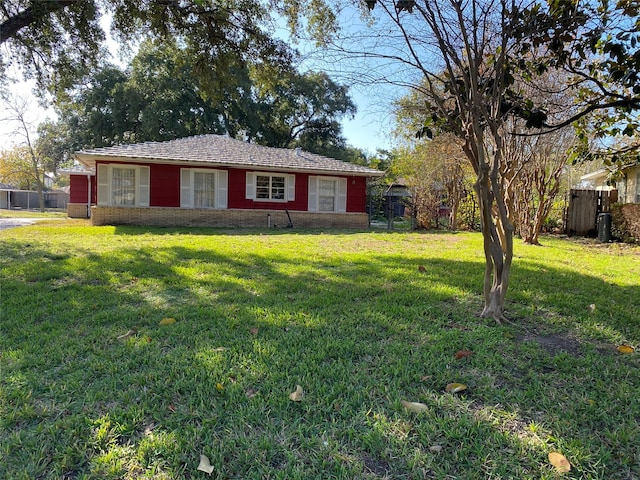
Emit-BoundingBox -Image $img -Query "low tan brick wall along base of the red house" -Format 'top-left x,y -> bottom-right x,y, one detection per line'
90,205 -> 369,229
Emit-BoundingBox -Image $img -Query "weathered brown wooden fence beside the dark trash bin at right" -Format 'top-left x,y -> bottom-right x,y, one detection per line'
566,190 -> 618,237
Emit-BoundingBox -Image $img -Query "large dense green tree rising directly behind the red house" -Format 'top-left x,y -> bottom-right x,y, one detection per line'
47,41 -> 355,159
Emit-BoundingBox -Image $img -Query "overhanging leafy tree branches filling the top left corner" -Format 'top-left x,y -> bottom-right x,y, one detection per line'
0,0 -> 290,99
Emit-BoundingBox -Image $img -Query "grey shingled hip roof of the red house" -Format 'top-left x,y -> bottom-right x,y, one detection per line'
75,135 -> 384,176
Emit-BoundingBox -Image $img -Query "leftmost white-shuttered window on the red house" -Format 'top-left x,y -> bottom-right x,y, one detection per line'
97,164 -> 150,207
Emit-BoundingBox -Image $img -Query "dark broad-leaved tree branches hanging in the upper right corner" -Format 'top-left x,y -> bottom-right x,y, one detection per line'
514,0 -> 640,163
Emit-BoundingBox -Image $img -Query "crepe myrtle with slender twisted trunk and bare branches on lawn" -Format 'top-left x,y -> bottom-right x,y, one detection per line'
347,0 -> 526,323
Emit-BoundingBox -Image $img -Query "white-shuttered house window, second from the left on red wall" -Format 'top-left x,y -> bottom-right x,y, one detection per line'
180,168 -> 228,208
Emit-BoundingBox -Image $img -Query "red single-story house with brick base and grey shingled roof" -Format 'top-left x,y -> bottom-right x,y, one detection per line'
68,135 -> 384,228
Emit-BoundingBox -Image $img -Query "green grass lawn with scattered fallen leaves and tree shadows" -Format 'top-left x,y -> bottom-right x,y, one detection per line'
0,221 -> 640,479
